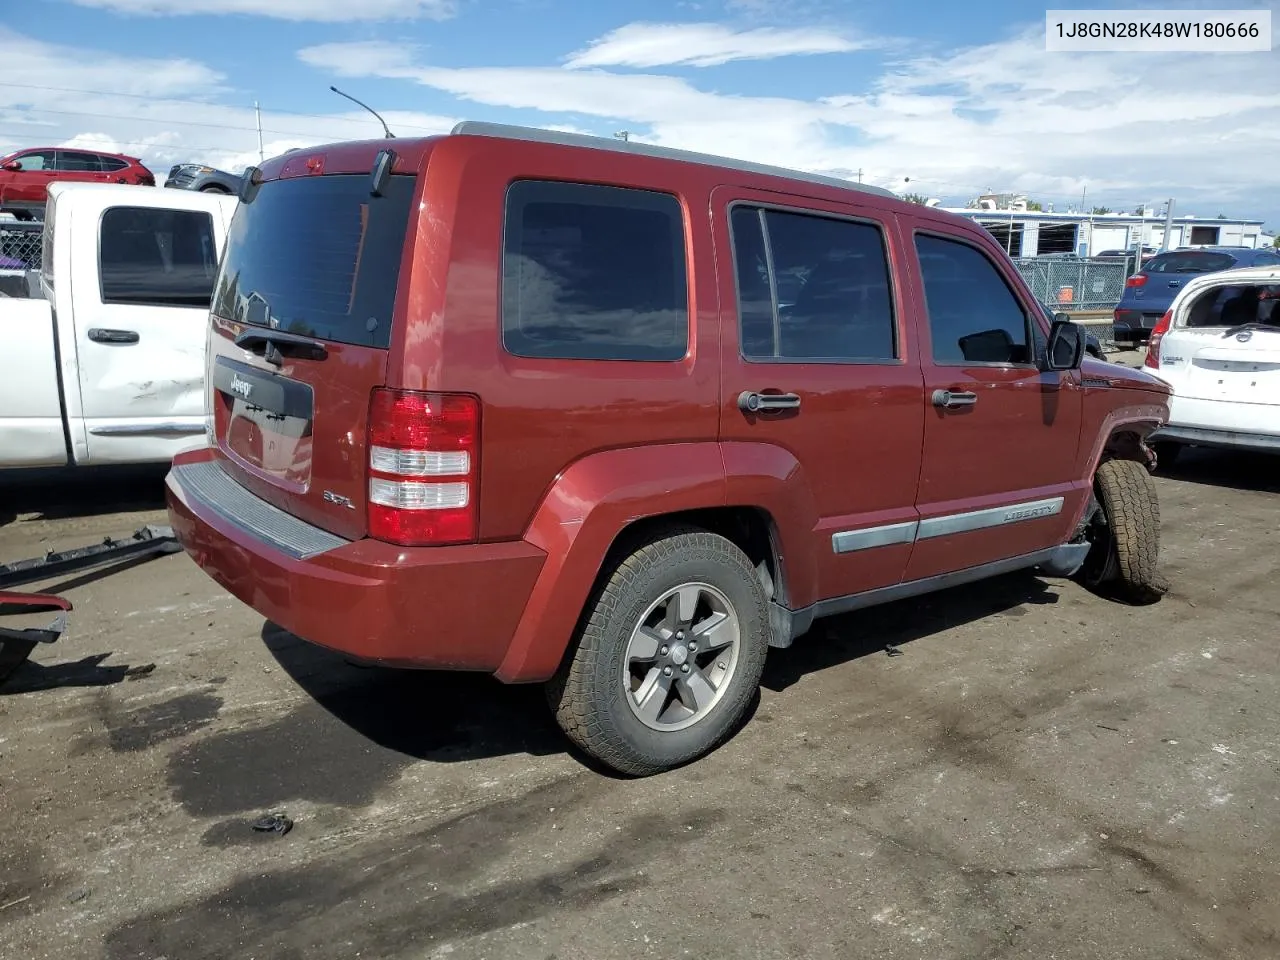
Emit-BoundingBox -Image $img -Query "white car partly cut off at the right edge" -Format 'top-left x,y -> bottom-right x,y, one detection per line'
1144,266 -> 1280,462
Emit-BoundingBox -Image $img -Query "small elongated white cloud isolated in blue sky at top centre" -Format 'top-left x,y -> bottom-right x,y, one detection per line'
567,23 -> 870,67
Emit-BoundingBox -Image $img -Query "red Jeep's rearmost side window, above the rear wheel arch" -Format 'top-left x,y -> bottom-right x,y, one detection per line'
502,180 -> 689,361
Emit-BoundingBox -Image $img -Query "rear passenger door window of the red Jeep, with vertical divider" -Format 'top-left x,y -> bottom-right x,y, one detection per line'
730,206 -> 897,362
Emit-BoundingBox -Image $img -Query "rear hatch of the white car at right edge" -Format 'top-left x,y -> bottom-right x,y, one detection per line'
1160,285 -> 1280,404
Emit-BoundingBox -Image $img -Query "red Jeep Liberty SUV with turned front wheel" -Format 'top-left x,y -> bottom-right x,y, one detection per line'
168,123 -> 1169,774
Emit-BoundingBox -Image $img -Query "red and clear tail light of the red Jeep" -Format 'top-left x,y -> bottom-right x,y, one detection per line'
369,389 -> 480,547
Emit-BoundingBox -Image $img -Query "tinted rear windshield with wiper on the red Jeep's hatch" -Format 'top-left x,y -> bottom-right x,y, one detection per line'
212,174 -> 416,349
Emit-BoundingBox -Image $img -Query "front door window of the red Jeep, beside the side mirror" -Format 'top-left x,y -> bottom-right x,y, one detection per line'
915,234 -> 1032,364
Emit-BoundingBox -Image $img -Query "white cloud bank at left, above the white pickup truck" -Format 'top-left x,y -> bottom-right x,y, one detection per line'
0,28 -> 457,179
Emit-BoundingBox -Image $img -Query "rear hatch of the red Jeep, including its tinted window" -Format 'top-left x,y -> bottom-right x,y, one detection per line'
207,146 -> 417,539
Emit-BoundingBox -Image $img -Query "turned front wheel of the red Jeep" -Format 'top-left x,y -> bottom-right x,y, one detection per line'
1080,460 -> 1169,604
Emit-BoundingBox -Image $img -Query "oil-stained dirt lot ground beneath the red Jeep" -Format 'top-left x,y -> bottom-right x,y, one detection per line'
0,454 -> 1280,960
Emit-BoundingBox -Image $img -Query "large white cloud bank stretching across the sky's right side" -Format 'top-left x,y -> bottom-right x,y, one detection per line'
300,26 -> 1280,224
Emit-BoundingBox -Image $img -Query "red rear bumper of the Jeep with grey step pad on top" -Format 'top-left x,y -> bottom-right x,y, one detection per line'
166,449 -> 545,672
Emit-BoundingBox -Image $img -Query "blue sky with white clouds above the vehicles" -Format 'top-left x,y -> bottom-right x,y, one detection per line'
0,0 -> 1280,230
